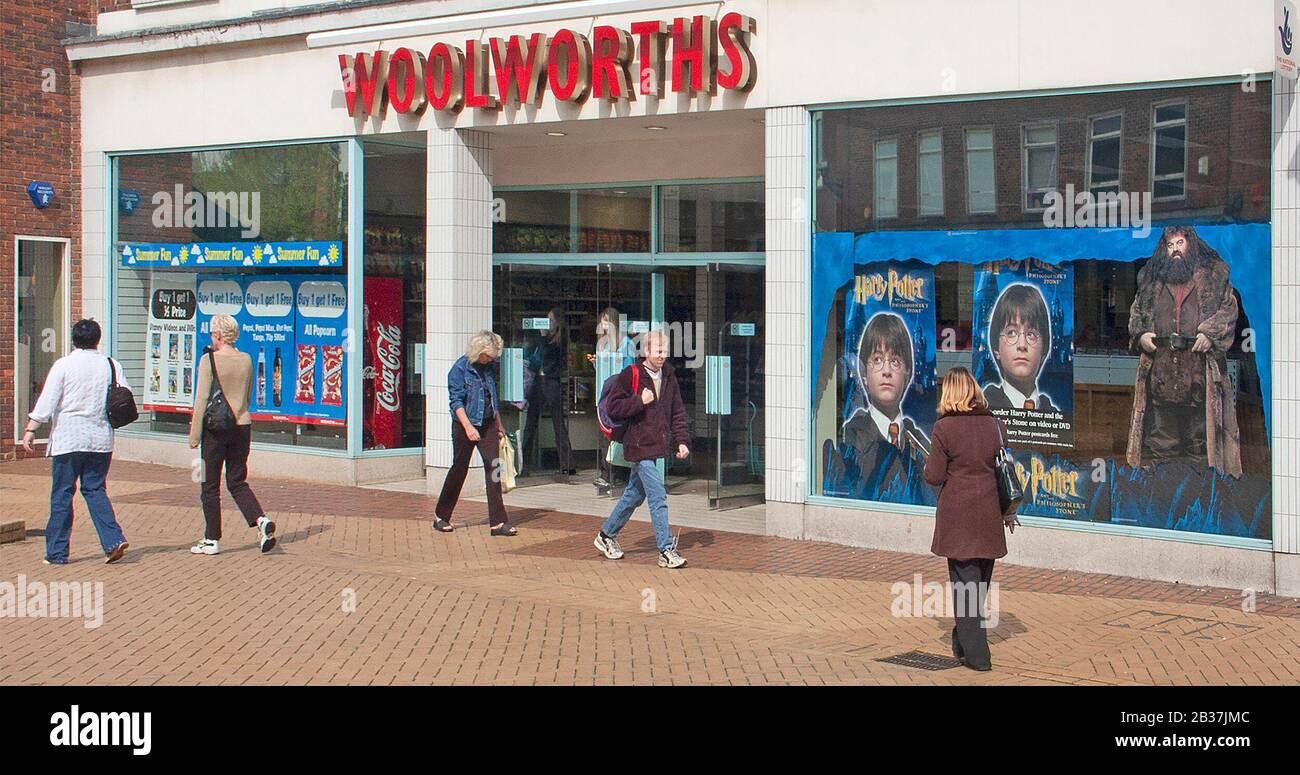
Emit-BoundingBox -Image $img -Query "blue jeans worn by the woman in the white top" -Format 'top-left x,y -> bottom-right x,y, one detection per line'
46,453 -> 126,563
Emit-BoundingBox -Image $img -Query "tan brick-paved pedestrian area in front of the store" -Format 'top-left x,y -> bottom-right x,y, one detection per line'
0,460 -> 1300,684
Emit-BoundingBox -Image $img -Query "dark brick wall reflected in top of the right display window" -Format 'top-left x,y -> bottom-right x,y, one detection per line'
816,82 -> 1270,231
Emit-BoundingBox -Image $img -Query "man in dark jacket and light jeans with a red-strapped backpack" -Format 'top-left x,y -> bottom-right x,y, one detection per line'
595,330 -> 690,568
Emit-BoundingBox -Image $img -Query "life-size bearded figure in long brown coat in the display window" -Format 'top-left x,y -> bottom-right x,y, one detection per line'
1127,226 -> 1242,477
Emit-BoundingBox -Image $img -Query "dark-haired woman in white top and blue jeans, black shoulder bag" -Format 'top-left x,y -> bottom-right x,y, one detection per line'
22,320 -> 130,564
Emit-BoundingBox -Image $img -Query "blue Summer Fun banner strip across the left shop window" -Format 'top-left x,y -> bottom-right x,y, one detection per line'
118,241 -> 343,269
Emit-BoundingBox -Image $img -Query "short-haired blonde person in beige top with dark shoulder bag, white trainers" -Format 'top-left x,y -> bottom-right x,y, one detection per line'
190,315 -> 276,554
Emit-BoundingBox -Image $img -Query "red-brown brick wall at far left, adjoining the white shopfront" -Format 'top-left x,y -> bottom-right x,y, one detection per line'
0,0 -> 96,459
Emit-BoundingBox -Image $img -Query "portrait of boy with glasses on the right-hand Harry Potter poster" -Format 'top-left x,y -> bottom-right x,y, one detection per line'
984,282 -> 1057,412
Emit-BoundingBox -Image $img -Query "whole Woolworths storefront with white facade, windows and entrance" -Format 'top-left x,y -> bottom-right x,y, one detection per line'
68,0 -> 1300,594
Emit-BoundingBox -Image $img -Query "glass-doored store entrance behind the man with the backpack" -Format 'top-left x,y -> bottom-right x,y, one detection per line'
493,263 -> 764,508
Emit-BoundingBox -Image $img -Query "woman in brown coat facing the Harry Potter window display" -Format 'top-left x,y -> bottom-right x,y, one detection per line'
926,367 -> 1019,670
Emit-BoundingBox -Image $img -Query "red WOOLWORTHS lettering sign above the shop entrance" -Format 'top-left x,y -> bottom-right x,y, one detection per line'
338,13 -> 757,117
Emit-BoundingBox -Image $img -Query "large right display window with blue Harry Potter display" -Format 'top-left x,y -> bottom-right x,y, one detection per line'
810,82 -> 1271,540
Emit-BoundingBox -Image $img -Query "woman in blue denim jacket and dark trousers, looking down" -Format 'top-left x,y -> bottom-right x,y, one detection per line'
433,330 -> 519,536
